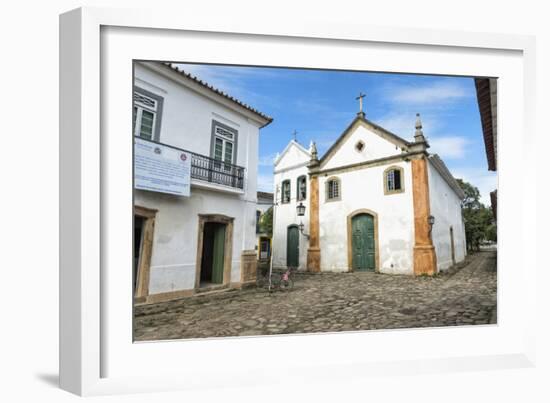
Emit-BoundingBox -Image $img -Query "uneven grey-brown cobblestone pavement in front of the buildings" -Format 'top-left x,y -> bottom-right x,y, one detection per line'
134,251 -> 497,341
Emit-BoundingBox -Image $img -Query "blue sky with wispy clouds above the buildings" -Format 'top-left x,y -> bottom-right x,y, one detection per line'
178,64 -> 497,205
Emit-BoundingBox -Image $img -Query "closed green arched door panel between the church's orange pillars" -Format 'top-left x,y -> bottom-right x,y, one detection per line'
351,214 -> 376,270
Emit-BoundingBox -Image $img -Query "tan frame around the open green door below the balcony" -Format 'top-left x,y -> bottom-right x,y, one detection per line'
195,214 -> 235,291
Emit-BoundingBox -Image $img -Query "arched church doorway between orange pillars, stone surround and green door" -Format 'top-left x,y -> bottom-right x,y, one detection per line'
348,209 -> 378,271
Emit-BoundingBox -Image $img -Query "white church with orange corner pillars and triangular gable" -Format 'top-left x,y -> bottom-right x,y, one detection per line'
273,112 -> 466,275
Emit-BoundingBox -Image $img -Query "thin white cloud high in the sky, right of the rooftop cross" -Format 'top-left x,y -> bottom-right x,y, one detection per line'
387,81 -> 470,106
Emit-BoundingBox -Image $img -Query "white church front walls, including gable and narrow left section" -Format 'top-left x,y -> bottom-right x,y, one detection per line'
273,125 -> 414,274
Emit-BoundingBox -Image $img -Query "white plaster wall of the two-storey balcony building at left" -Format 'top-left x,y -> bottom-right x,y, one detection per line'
134,64 -> 260,294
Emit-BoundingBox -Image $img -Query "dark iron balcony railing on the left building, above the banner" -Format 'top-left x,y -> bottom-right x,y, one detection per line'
135,137 -> 244,189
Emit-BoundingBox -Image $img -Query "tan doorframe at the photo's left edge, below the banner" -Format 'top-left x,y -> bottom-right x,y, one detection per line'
132,206 -> 158,298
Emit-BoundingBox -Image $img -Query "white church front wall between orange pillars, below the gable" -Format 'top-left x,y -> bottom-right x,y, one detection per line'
319,162 -> 414,274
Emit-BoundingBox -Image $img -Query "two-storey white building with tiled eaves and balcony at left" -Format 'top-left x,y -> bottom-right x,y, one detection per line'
133,62 -> 272,302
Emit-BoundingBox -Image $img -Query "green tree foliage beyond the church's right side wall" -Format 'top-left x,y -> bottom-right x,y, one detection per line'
457,179 -> 496,251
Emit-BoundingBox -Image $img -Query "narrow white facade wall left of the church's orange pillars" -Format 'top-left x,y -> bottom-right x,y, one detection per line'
272,143 -> 310,270
